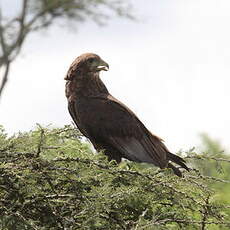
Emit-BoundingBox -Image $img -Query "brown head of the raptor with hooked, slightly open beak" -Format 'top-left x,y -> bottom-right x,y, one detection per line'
65,53 -> 109,80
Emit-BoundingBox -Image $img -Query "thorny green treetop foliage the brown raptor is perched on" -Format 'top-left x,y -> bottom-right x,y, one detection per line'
0,125 -> 230,230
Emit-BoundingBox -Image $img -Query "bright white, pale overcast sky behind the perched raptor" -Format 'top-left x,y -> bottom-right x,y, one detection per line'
0,0 -> 230,151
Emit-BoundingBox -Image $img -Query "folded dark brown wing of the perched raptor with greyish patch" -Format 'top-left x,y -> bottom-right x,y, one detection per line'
83,95 -> 168,168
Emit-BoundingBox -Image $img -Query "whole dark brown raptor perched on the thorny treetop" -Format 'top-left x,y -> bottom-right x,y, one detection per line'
65,53 -> 189,176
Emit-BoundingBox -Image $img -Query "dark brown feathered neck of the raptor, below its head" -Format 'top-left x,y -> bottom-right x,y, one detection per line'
69,73 -> 109,97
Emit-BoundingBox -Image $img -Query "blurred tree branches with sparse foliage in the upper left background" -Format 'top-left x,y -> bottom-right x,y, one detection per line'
0,0 -> 132,97
